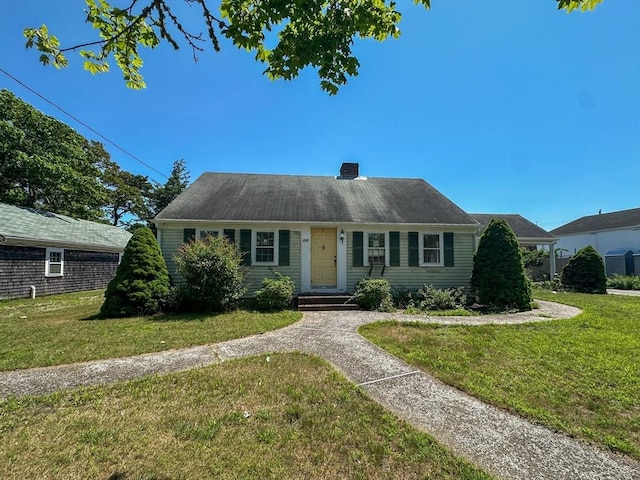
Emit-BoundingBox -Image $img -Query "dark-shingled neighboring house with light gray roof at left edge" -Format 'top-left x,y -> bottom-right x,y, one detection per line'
0,203 -> 131,300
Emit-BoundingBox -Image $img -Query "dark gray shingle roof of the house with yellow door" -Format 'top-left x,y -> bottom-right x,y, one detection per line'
156,173 -> 477,225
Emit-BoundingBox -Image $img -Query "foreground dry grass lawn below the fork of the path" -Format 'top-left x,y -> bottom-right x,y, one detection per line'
0,354 -> 491,480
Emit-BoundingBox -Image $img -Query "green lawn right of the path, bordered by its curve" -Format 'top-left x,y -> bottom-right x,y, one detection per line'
360,291 -> 640,459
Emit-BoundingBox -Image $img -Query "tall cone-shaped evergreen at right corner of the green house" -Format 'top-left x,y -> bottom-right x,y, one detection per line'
471,218 -> 531,310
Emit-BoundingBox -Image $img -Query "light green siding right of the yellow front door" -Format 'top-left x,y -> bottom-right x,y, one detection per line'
347,229 -> 474,292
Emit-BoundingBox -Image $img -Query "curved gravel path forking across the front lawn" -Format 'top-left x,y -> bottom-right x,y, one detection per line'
0,301 -> 640,480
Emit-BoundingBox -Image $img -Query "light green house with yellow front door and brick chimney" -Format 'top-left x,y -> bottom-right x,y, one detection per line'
154,163 -> 478,293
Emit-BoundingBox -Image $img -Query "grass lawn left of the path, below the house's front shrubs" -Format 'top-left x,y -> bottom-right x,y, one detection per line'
0,290 -> 302,370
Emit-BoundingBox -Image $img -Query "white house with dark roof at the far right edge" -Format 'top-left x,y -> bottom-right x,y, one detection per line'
551,208 -> 640,275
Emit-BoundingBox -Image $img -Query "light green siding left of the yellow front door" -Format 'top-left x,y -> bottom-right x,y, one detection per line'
160,226 -> 302,296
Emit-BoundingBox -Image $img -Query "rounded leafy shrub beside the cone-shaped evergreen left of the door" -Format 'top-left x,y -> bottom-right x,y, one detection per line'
173,236 -> 246,312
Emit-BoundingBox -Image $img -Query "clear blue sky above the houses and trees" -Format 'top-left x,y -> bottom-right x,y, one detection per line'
0,0 -> 640,230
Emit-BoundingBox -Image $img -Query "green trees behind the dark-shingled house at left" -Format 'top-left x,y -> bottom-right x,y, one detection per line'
0,90 -> 189,226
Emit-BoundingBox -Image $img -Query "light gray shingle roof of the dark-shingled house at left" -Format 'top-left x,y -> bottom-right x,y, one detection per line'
0,203 -> 131,250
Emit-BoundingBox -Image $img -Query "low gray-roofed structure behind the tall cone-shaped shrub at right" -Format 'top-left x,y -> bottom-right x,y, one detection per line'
470,213 -> 557,278
